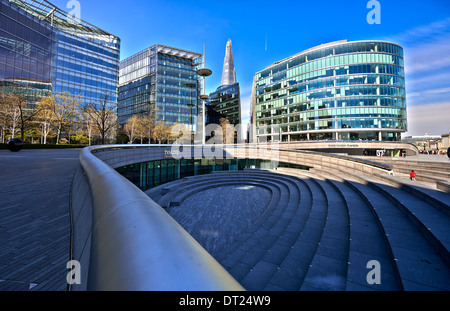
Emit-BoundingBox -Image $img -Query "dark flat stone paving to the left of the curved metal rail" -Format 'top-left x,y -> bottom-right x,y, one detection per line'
0,149 -> 80,291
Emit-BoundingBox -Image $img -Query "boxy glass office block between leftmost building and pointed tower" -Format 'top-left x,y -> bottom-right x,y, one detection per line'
118,44 -> 203,129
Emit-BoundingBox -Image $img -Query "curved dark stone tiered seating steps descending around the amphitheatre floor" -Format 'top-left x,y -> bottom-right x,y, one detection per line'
147,169 -> 450,291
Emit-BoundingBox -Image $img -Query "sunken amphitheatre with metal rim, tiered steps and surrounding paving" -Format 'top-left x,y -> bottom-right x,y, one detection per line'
0,142 -> 450,291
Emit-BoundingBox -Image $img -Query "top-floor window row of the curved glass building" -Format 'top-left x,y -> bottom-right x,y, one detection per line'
256,42 -> 403,80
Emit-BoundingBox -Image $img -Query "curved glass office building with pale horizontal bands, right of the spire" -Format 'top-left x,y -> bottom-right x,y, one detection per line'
250,40 -> 407,142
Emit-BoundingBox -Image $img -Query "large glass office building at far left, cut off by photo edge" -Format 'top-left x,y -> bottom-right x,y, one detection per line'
0,0 -> 120,105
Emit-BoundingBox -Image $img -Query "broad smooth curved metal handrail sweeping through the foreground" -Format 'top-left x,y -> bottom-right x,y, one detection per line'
80,147 -> 245,291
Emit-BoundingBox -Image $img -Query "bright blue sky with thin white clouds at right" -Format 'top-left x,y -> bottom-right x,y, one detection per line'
50,0 -> 450,135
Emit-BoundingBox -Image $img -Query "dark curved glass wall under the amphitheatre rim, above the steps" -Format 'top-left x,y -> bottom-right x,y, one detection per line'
116,158 -> 309,191
